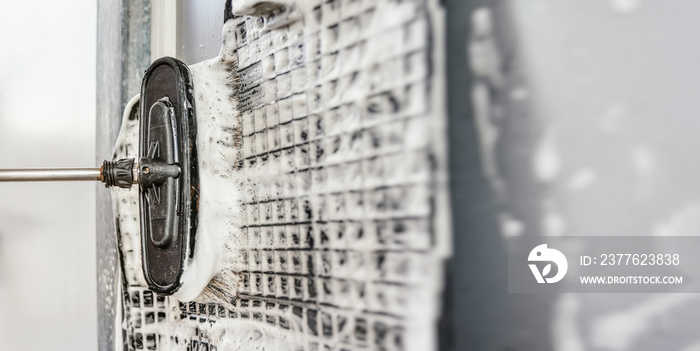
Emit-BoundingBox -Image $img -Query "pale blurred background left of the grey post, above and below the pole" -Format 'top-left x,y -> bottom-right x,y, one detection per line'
0,0 -> 97,350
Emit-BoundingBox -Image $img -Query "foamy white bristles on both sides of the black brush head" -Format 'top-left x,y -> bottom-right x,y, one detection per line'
112,22 -> 247,308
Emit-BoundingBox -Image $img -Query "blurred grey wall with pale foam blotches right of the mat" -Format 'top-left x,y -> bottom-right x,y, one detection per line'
445,0 -> 700,351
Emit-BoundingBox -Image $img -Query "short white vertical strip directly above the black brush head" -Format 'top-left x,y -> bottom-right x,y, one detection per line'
151,0 -> 179,61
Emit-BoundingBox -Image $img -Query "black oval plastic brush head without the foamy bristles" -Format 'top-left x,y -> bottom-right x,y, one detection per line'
138,57 -> 199,295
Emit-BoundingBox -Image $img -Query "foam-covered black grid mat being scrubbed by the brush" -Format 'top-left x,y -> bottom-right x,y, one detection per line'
119,0 -> 444,350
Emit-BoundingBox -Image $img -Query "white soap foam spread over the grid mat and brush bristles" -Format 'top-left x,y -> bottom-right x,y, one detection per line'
111,1 -> 450,350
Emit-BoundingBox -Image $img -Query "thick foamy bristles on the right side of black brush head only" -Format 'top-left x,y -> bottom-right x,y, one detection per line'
173,21 -> 243,306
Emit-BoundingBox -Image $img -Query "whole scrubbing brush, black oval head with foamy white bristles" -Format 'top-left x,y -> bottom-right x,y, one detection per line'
106,19 -> 245,307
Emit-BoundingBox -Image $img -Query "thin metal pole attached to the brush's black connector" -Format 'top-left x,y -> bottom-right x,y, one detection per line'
0,168 -> 102,182
